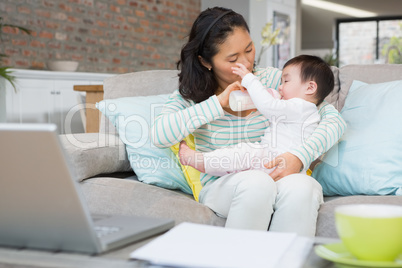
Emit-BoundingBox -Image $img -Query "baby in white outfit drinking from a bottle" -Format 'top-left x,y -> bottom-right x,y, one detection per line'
179,55 -> 334,176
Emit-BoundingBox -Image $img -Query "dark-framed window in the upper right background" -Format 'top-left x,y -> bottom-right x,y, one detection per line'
336,17 -> 402,66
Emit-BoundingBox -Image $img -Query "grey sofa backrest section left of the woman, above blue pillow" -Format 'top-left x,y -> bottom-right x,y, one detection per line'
99,70 -> 179,134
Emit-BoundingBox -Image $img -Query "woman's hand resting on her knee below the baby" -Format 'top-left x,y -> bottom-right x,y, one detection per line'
264,153 -> 303,181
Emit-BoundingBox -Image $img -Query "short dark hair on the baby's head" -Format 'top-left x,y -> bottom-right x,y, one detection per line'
283,55 -> 335,105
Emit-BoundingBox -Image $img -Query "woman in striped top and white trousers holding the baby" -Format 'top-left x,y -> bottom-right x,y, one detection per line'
152,7 -> 345,236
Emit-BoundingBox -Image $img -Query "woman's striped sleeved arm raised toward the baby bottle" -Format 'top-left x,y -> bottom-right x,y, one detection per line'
151,91 -> 224,148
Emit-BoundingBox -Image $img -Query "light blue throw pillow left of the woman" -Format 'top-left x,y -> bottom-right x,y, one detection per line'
96,94 -> 192,194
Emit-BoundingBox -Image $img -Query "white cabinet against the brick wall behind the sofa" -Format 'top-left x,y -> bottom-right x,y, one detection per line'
0,69 -> 113,134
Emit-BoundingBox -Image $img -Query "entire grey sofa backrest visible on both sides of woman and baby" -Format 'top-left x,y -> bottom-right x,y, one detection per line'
99,64 -> 402,133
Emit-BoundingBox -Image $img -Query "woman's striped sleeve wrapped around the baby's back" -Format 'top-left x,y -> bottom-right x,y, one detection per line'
290,101 -> 346,171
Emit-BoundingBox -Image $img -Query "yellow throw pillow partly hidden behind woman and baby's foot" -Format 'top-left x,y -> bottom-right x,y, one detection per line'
170,135 -> 202,202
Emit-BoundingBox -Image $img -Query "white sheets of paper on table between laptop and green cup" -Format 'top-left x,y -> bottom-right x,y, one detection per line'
130,223 -> 297,268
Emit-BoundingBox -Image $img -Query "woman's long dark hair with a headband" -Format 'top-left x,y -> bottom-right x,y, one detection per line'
177,7 -> 250,103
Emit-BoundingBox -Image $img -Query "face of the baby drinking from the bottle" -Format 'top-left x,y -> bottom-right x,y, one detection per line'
278,65 -> 308,100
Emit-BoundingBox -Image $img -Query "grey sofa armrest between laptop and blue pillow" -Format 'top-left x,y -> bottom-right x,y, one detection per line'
60,133 -> 132,181
